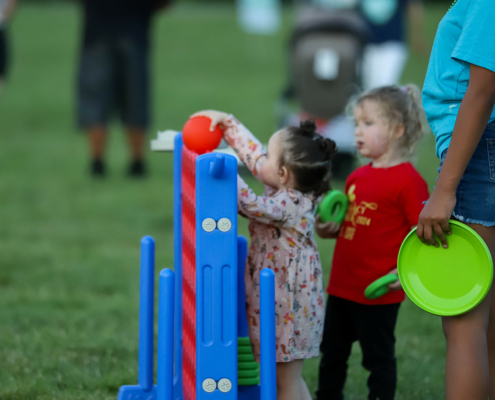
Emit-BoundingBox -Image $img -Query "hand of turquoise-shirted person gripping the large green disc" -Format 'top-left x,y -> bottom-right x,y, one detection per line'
416,190 -> 456,249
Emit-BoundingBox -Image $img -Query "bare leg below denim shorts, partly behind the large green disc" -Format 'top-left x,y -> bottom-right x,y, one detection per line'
442,224 -> 495,400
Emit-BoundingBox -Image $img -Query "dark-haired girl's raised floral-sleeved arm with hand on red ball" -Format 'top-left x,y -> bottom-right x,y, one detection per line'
192,110 -> 266,179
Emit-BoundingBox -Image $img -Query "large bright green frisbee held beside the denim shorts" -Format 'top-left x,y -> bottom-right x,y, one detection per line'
397,220 -> 493,316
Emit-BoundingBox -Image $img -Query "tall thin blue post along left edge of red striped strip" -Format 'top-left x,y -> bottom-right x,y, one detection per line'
174,133 -> 184,400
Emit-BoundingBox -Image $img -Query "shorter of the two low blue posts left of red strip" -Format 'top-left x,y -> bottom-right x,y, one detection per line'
156,268 -> 174,400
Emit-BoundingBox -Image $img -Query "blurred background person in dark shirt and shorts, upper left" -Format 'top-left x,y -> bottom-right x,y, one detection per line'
76,0 -> 170,178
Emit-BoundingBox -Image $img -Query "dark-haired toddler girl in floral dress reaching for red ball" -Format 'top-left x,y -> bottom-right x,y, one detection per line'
194,111 -> 336,400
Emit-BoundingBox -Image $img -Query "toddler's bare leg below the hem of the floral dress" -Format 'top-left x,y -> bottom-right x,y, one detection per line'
277,360 -> 311,400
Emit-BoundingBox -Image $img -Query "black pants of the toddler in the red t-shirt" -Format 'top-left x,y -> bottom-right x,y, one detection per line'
316,295 -> 401,400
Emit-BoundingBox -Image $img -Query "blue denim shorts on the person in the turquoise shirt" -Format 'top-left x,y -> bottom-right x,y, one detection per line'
438,123 -> 495,227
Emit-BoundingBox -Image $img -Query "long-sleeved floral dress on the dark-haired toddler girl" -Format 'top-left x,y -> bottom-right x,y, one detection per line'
224,116 -> 325,362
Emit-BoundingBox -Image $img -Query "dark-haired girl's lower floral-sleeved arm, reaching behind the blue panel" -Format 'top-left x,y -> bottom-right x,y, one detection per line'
237,175 -> 295,226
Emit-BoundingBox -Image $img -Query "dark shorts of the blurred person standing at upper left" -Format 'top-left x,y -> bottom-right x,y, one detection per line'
78,35 -> 149,129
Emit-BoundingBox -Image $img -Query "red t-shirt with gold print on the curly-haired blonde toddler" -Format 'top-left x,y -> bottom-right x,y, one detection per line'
327,163 -> 429,304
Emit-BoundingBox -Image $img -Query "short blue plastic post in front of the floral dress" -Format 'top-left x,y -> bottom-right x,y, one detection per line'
260,268 -> 277,400
